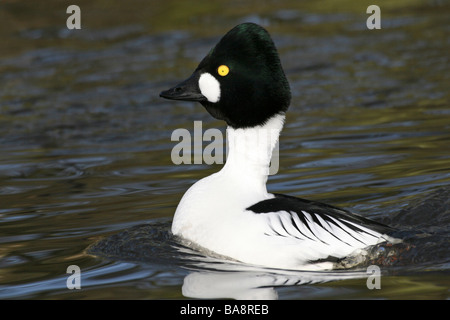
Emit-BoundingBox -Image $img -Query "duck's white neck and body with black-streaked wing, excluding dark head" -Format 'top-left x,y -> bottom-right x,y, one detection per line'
172,115 -> 388,269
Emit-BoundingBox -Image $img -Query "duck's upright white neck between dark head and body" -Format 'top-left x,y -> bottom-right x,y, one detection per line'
221,114 -> 285,188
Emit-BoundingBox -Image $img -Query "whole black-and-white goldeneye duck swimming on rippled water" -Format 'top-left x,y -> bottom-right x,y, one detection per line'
160,22 -> 395,270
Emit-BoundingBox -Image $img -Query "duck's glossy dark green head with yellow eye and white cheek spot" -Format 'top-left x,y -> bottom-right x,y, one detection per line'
160,23 -> 291,129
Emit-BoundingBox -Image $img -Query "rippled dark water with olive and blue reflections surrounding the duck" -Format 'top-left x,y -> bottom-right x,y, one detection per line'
0,1 -> 450,299
